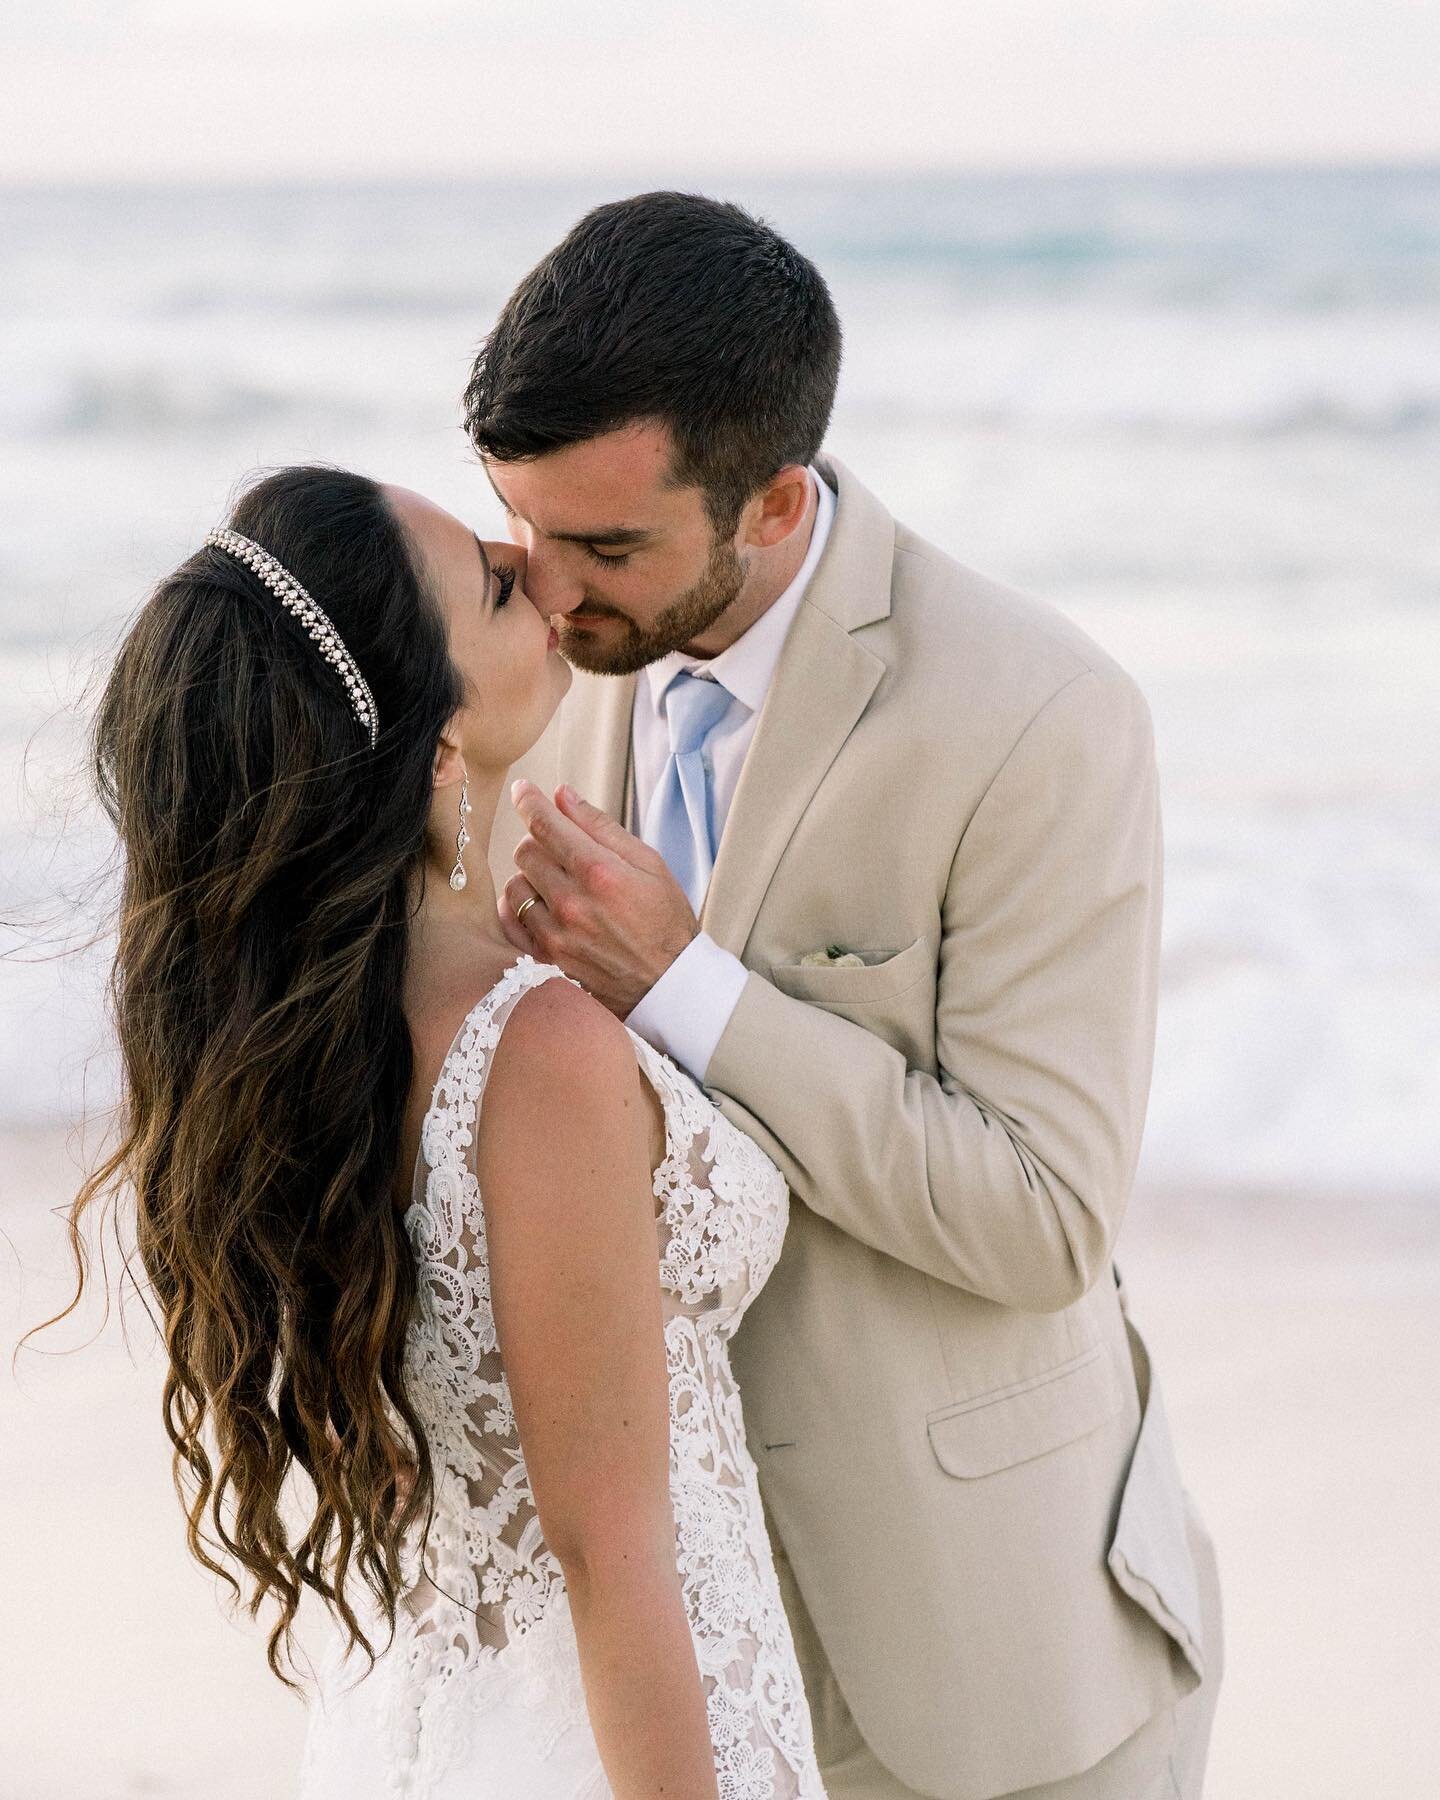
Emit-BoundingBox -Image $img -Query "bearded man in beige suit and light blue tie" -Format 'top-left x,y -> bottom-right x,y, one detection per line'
466,193 -> 1222,1800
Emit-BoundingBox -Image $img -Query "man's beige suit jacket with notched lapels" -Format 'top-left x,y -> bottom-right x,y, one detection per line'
491,461 -> 1204,1800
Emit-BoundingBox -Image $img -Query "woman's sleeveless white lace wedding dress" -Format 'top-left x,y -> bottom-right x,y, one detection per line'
301,956 -> 824,1800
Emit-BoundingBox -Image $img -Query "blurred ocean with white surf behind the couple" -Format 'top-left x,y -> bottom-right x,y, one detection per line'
0,169 -> 1440,1195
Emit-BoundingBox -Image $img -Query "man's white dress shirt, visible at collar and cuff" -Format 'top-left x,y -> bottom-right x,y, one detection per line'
625,468 -> 835,1082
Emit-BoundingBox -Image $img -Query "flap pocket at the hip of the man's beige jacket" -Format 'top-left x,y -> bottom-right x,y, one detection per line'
925,1345 -> 1125,1478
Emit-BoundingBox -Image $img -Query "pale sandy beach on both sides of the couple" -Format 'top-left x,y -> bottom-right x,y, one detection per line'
0,1136 -> 1440,1800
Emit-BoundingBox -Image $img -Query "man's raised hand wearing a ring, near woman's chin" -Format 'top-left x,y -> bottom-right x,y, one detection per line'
499,781 -> 700,1019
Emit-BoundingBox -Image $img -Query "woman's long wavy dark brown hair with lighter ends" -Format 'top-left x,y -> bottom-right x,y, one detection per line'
33,468 -> 463,1687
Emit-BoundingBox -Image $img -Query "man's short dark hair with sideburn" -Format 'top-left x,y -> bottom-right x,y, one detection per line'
464,193 -> 841,533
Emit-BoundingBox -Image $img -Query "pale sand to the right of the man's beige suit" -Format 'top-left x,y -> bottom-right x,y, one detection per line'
1118,1193 -> 1440,1800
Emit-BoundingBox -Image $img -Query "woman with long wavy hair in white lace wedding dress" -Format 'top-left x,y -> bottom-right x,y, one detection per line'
62,468 -> 823,1800
